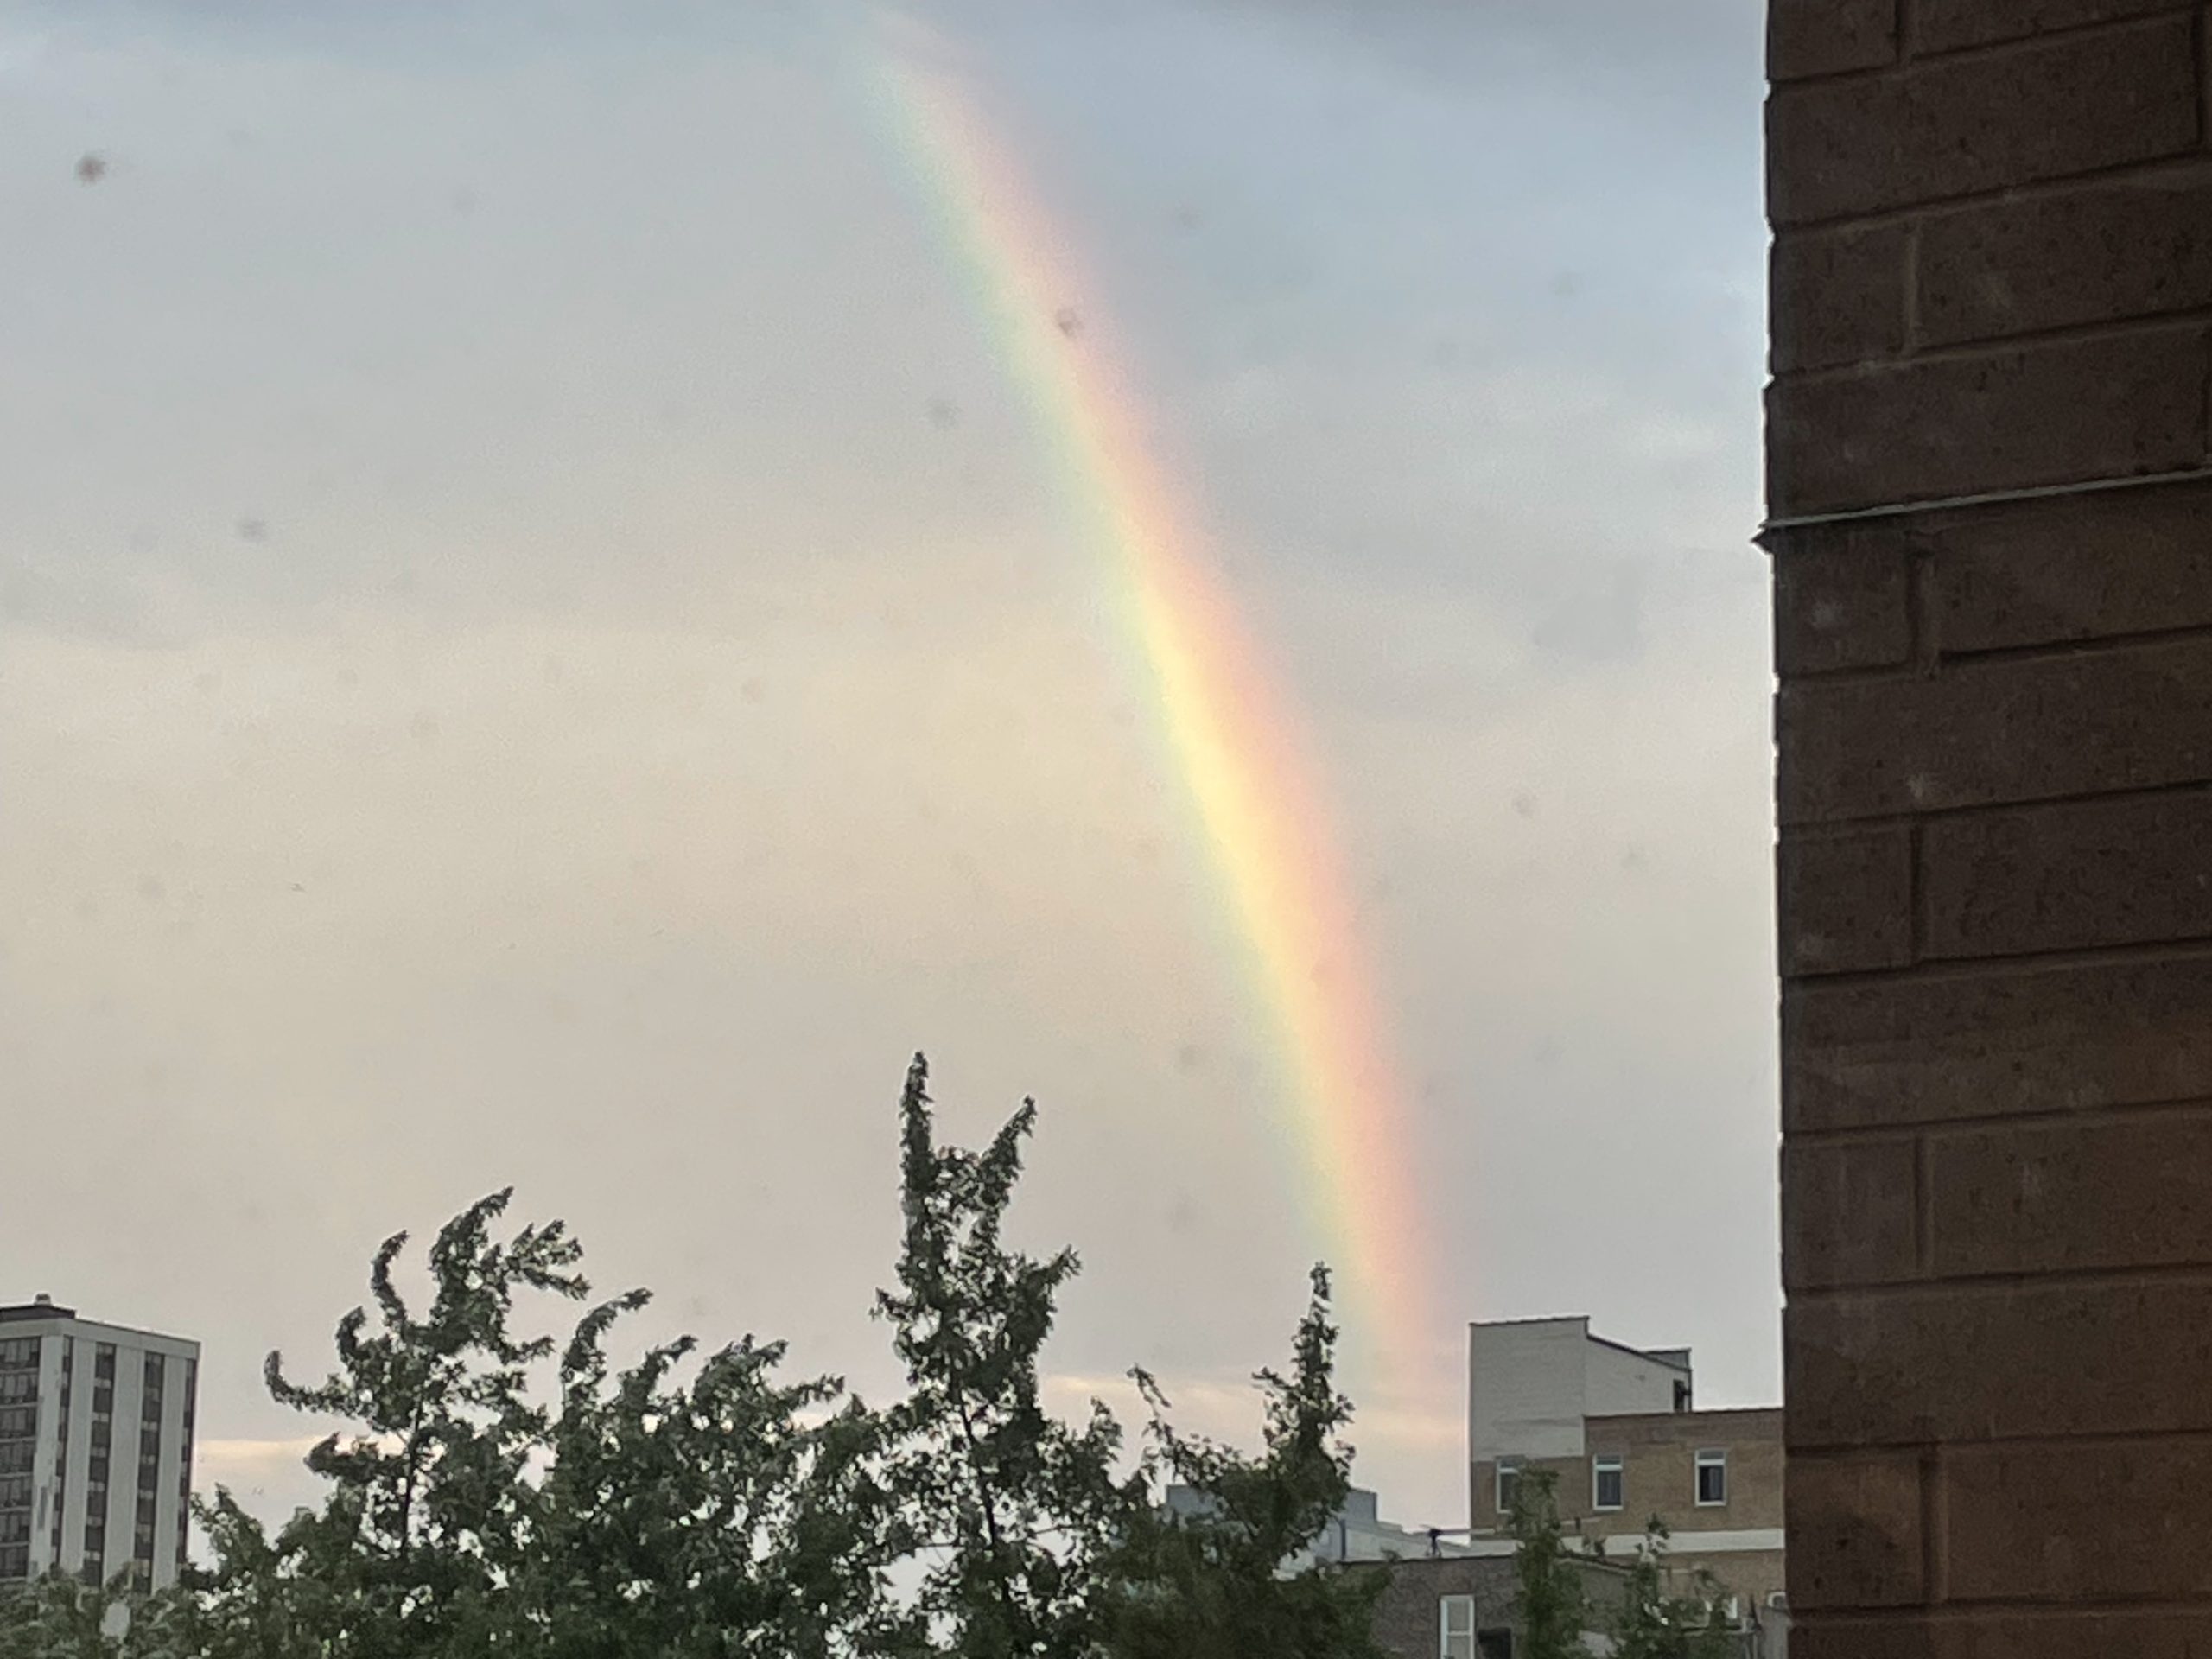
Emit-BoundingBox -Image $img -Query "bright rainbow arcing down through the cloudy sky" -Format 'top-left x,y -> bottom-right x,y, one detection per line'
869,20 -> 1449,1382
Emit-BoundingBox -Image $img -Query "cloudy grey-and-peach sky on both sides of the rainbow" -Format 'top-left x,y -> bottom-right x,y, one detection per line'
0,0 -> 1778,1524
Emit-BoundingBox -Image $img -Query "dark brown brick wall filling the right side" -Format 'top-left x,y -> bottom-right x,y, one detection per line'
1765,0 -> 2212,1659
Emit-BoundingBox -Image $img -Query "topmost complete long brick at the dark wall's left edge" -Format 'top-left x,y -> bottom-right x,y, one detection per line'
1767,17 -> 2199,226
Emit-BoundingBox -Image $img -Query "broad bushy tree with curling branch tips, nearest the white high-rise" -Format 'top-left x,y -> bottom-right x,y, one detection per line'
193,1192 -> 889,1659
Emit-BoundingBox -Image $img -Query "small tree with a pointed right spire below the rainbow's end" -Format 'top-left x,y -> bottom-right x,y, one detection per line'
1106,1268 -> 1387,1659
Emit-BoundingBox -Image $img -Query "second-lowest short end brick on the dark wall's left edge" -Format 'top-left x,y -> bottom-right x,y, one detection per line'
1783,1137 -> 1918,1292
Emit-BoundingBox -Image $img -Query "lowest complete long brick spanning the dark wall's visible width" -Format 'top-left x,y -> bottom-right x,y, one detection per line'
1783,1279 -> 2212,1451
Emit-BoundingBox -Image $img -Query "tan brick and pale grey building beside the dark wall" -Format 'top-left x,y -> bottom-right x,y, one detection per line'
1466,1319 -> 1787,1655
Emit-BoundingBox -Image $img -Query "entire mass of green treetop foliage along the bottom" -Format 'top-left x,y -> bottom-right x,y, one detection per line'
0,1058 -> 1380,1659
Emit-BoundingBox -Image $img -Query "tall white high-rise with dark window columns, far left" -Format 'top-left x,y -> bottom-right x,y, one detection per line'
0,1296 -> 199,1588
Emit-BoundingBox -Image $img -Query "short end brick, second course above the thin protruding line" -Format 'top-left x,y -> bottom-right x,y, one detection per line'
1767,226 -> 1911,374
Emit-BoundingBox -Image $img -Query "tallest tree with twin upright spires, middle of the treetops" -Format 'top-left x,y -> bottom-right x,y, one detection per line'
876,1055 -> 1141,1659
